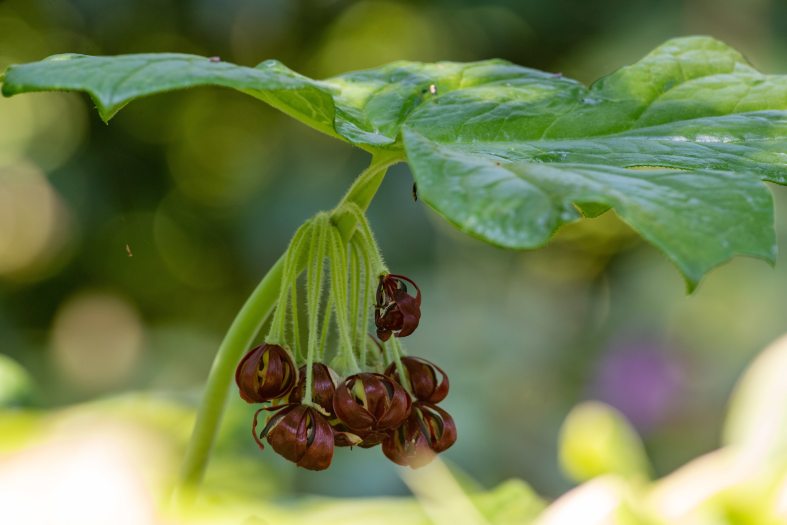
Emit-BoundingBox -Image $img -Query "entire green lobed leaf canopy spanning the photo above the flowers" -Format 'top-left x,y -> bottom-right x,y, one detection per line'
3,37 -> 787,289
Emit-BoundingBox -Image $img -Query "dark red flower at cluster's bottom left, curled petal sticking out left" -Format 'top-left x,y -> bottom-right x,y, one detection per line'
252,403 -> 334,470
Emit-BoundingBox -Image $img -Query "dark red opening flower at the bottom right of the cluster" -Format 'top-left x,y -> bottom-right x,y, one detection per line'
383,401 -> 456,468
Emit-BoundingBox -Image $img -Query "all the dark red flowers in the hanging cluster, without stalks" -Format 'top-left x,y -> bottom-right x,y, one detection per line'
235,274 -> 456,470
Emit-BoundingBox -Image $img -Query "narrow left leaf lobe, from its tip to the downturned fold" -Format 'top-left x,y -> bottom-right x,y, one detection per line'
3,53 -> 336,136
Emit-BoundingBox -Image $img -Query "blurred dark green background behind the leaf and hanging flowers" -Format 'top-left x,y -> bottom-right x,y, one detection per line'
0,0 -> 787,504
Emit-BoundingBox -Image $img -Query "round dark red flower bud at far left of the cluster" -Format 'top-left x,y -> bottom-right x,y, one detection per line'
235,343 -> 298,403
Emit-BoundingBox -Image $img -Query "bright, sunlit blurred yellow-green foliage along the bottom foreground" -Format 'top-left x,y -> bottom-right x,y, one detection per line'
0,330 -> 787,525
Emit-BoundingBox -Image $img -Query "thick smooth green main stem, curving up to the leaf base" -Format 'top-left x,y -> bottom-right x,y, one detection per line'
176,148 -> 401,497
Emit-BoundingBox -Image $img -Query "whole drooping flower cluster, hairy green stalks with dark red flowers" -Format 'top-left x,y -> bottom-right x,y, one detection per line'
236,204 -> 456,470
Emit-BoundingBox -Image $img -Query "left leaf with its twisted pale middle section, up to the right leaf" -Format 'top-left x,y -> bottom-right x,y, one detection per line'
3,53 -> 511,149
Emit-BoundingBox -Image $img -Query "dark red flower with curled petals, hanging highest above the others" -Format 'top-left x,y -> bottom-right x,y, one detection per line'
374,273 -> 421,341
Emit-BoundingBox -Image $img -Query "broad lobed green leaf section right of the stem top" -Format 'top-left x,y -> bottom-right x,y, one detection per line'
403,37 -> 787,289
